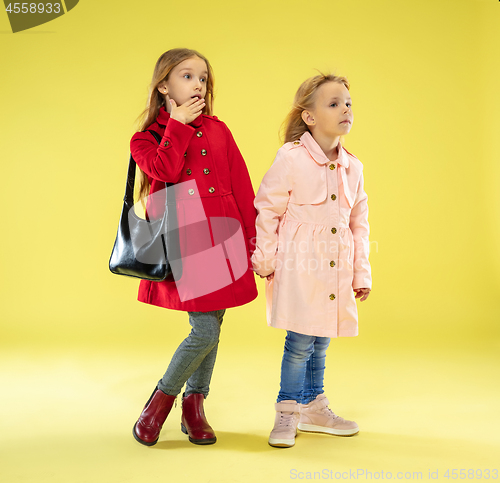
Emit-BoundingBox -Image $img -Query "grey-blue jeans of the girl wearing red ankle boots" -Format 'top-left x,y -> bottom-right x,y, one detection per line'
158,309 -> 226,397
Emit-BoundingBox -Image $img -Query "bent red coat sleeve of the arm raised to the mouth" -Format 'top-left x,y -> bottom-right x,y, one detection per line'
130,119 -> 195,183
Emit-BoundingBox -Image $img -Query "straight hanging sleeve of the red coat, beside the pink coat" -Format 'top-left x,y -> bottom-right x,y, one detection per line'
225,126 -> 257,255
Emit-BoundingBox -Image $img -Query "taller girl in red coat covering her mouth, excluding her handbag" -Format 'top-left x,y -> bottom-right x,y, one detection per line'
130,49 -> 257,446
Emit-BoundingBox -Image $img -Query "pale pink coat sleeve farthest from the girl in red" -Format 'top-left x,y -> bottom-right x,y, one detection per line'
349,172 -> 372,289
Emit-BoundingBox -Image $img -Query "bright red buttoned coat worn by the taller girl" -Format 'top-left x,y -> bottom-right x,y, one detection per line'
130,107 -> 257,312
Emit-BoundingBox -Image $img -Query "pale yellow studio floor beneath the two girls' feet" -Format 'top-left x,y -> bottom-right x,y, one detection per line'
0,340 -> 500,483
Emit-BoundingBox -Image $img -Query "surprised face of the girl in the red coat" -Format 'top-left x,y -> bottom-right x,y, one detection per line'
158,57 -> 208,106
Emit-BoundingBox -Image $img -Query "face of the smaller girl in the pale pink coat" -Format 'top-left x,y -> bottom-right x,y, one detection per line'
303,82 -> 353,138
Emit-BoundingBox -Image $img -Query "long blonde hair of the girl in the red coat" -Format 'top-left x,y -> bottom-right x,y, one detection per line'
138,48 -> 214,200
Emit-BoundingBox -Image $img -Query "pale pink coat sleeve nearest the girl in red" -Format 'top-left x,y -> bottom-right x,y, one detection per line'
252,150 -> 292,276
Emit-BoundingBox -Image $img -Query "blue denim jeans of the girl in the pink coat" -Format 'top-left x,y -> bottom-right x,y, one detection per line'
277,330 -> 330,404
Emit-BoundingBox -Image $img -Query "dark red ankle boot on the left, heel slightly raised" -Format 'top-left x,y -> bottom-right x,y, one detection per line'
133,388 -> 177,446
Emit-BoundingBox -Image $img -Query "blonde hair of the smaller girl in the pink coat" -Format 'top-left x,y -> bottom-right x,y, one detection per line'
281,72 -> 350,143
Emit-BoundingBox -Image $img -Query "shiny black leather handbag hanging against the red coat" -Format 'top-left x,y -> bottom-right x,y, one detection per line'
109,131 -> 180,282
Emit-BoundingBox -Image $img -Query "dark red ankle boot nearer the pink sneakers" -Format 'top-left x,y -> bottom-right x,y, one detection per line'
181,394 -> 217,444
